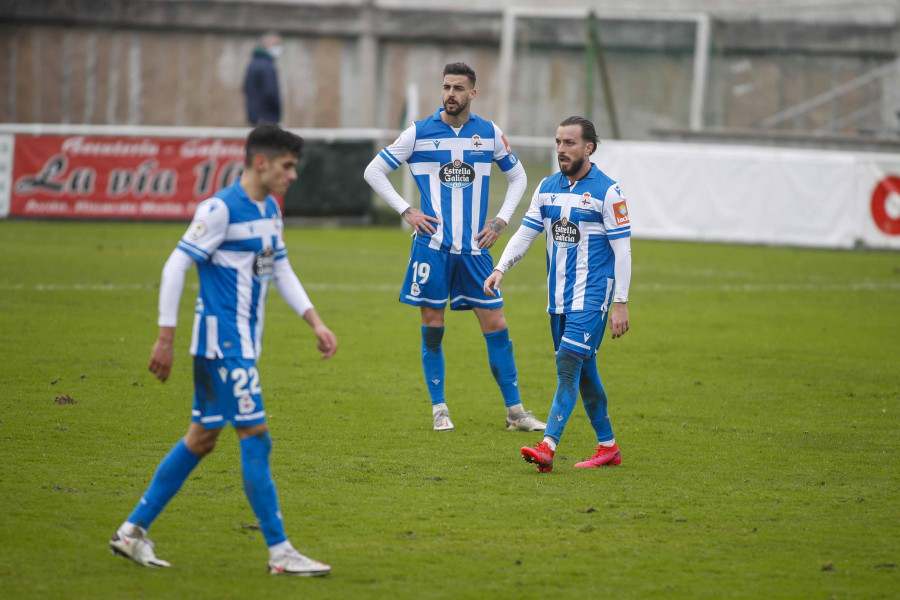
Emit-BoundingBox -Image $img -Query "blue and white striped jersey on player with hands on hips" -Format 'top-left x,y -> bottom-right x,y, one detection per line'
379,108 -> 519,254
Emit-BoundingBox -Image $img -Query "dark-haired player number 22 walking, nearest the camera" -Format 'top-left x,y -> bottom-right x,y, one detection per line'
110,124 -> 337,575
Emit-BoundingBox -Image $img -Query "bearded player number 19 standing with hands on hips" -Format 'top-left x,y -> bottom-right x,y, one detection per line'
365,63 -> 546,431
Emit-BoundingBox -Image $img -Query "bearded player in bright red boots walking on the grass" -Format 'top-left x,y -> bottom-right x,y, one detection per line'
484,117 -> 631,472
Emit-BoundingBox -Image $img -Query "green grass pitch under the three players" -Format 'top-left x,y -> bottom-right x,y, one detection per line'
0,219 -> 900,600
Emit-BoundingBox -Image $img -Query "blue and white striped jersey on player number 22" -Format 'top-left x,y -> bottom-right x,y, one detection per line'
178,181 -> 287,359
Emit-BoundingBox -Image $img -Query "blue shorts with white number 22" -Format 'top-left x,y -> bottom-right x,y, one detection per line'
191,356 -> 266,429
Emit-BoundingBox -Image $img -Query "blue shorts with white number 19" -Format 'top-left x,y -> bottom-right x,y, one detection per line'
400,241 -> 503,310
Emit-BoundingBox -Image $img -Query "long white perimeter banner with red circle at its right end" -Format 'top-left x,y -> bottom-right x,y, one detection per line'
592,142 -> 900,248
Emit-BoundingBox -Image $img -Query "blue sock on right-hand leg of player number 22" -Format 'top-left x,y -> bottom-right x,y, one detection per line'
241,431 -> 287,546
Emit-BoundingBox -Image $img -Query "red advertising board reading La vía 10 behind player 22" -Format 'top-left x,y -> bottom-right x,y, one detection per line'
9,135 -> 250,220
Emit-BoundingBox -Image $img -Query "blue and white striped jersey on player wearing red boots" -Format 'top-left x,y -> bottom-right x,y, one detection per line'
522,164 -> 631,314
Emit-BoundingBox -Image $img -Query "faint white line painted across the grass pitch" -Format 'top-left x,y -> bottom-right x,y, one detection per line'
0,281 -> 900,293
